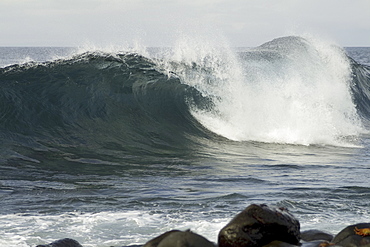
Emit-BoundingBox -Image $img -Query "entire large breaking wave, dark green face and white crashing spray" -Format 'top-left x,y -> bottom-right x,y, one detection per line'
0,37 -> 370,153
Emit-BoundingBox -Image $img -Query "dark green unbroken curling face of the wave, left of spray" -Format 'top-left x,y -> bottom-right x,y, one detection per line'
0,52 -> 212,158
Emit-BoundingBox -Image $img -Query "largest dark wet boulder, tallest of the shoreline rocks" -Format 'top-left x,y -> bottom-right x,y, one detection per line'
218,204 -> 300,247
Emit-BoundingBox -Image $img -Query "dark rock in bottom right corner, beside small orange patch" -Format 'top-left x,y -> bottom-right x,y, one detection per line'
332,223 -> 370,247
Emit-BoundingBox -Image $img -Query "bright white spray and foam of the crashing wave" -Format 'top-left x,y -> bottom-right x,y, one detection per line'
169,37 -> 363,146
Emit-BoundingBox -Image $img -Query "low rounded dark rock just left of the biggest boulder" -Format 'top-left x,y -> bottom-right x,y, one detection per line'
143,230 -> 215,247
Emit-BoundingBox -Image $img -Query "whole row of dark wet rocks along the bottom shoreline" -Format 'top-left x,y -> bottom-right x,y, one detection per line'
36,204 -> 370,247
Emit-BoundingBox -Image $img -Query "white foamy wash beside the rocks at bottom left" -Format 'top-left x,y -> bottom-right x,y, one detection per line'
0,211 -> 228,247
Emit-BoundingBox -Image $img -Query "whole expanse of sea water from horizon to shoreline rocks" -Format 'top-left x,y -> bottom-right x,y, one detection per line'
0,37 -> 370,247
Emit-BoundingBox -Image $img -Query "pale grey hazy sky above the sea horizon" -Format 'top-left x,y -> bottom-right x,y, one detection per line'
0,0 -> 370,47
